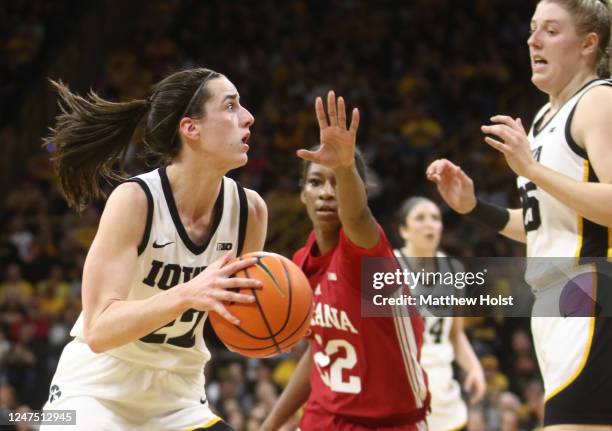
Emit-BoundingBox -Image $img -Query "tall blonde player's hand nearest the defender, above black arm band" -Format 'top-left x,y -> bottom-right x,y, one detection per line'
425,159 -> 476,214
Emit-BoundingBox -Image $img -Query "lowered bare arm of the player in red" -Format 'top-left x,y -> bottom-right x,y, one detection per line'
261,346 -> 312,431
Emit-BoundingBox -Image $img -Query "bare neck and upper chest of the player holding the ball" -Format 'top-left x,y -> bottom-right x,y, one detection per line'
166,162 -> 224,221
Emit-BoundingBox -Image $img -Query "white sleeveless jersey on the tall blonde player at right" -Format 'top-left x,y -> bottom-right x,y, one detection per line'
517,79 -> 612,293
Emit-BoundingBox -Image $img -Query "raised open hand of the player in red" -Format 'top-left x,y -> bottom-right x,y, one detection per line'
297,91 -> 359,169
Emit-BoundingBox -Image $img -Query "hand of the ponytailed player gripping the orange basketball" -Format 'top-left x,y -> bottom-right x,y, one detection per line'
180,254 -> 261,325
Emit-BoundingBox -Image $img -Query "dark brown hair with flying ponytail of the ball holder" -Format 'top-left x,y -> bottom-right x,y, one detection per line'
44,68 -> 221,210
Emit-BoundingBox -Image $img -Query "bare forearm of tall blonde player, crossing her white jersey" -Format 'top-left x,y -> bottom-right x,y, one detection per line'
529,163 -> 612,228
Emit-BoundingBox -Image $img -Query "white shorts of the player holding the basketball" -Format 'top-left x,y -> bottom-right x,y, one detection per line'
41,339 -> 220,431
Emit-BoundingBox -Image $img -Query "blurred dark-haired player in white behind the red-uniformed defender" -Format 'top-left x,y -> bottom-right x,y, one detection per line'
393,196 -> 486,431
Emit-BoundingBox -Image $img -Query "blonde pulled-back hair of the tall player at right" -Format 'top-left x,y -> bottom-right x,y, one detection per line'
541,0 -> 612,78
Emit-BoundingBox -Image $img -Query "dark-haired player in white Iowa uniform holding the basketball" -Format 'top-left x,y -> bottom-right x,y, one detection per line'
39,69 -> 267,430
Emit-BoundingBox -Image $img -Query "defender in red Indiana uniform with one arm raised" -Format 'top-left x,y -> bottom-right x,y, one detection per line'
263,92 -> 429,431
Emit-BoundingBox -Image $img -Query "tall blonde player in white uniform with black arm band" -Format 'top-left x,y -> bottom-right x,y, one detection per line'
427,0 -> 612,430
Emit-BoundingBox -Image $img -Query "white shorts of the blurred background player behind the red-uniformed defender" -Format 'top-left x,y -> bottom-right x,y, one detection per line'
425,366 -> 468,431
